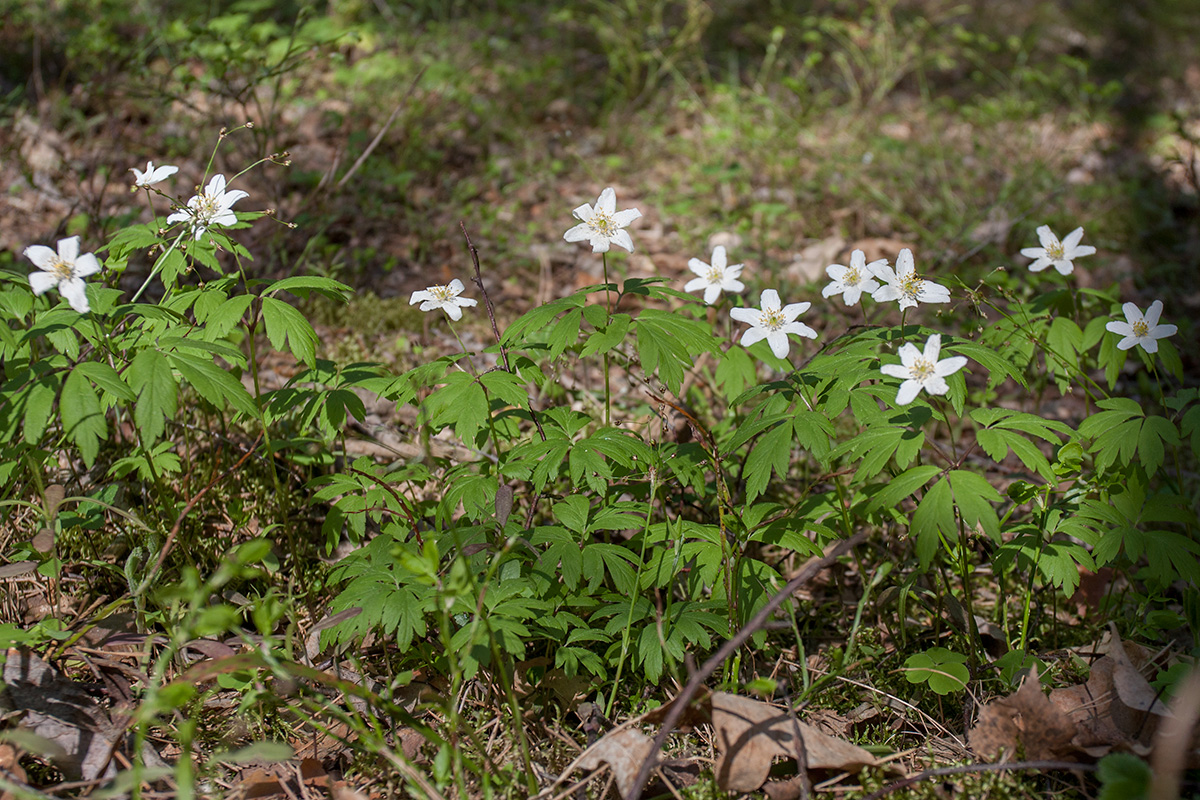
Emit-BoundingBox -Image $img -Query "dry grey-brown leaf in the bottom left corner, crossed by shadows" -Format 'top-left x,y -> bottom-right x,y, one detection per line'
0,649 -> 124,781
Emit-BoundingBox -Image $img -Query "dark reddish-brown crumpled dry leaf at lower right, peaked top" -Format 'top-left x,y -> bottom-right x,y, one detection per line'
967,668 -> 1075,760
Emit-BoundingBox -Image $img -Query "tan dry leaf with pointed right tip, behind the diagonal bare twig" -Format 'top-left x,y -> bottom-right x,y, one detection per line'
712,692 -> 878,792
